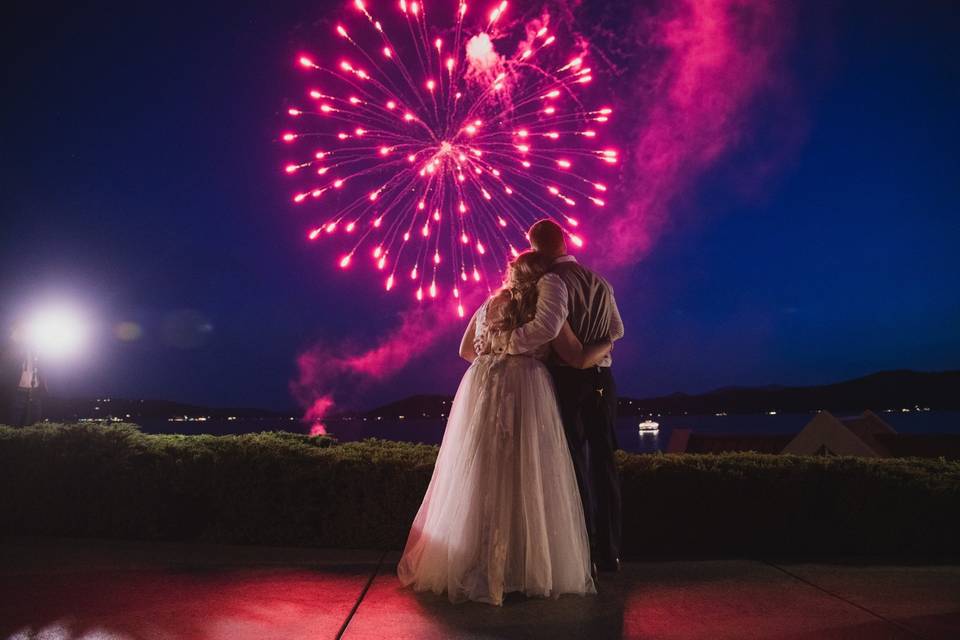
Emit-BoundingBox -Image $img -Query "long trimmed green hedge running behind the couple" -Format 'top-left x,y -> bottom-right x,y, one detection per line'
0,424 -> 960,557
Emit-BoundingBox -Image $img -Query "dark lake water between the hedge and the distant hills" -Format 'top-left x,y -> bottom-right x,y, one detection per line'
142,411 -> 960,453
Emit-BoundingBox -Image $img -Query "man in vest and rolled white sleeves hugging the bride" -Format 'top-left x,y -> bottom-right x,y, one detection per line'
509,220 -> 623,571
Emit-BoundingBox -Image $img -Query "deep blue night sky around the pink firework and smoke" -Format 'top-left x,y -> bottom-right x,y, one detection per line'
0,0 -> 960,408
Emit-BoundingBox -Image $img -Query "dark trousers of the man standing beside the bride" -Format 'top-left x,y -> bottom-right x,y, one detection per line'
550,366 -> 621,567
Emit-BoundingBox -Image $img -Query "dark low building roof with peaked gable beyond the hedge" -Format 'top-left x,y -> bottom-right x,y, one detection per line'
667,411 -> 960,460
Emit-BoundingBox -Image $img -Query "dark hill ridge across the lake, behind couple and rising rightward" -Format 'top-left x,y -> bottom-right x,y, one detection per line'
351,370 -> 960,419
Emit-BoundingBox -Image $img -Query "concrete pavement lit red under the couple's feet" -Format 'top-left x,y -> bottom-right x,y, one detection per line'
0,539 -> 960,640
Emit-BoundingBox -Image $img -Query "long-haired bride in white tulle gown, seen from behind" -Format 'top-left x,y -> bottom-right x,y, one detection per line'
397,251 -> 610,605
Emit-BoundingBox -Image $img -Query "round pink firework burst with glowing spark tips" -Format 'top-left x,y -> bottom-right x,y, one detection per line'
282,0 -> 617,316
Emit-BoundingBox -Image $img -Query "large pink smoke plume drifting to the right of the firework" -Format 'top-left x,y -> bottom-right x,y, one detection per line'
593,0 -> 787,268
